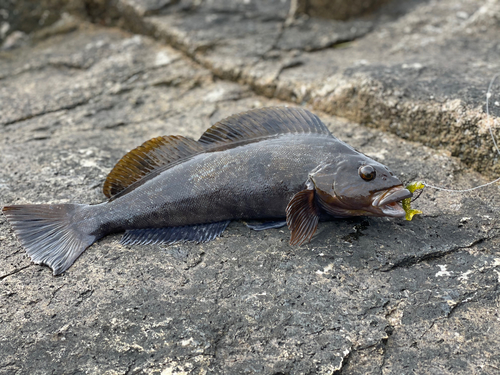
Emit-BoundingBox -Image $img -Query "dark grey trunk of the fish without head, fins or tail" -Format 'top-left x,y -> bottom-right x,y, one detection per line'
95,134 -> 355,231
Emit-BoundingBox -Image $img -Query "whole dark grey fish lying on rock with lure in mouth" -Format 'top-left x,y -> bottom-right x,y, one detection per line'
2,107 -> 412,275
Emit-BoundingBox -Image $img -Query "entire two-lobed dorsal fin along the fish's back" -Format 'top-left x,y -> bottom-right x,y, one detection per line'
103,107 -> 331,198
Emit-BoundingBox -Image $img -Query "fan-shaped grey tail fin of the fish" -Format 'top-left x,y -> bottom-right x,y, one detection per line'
2,204 -> 97,275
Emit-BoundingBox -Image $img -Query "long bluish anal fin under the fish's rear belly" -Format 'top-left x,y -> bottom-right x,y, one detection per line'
121,220 -> 230,245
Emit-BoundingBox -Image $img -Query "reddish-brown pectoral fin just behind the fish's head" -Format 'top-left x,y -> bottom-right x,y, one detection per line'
286,189 -> 319,245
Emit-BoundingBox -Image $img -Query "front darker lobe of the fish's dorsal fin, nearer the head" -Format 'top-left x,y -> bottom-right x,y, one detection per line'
198,107 -> 331,144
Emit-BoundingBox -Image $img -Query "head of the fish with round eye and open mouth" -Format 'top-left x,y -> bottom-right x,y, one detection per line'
309,154 -> 412,217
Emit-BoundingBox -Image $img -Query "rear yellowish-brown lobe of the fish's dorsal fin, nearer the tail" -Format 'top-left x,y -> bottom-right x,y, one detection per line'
103,135 -> 204,198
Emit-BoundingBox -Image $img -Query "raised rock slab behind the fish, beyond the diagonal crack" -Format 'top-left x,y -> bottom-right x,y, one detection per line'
110,0 -> 500,176
